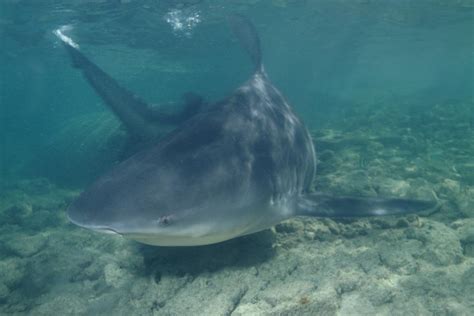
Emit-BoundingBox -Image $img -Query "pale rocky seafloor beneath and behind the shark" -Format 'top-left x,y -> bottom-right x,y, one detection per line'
0,101 -> 474,315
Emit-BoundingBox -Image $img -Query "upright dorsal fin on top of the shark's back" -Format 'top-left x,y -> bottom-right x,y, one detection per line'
229,14 -> 263,72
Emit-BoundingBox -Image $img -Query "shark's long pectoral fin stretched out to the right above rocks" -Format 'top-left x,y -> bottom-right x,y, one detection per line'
297,193 -> 438,217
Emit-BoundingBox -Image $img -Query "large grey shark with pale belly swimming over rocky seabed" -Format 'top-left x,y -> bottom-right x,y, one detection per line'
57,15 -> 434,246
